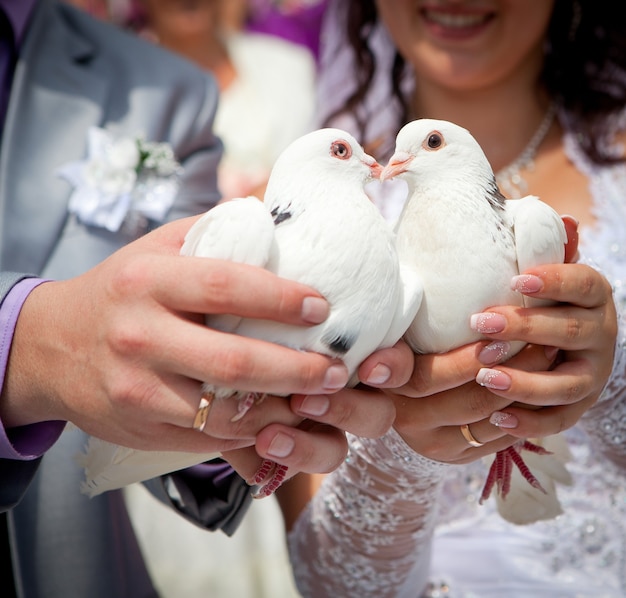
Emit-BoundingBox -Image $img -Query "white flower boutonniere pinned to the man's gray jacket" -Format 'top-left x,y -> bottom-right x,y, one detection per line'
57,127 -> 182,232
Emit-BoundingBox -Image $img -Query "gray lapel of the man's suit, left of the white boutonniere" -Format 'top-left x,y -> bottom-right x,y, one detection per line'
0,1 -> 108,273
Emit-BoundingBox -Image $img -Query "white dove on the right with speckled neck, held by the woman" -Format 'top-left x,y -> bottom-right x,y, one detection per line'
381,119 -> 567,520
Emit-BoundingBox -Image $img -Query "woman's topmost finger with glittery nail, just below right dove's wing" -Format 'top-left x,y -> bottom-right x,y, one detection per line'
512,264 -> 612,307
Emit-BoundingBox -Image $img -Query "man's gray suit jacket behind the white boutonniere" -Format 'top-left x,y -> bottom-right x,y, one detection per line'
0,0 -> 236,598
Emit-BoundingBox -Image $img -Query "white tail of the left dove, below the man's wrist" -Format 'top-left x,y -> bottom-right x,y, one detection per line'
77,436 -> 220,498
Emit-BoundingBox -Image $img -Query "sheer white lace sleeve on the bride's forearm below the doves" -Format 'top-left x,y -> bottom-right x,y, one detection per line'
289,430 -> 454,598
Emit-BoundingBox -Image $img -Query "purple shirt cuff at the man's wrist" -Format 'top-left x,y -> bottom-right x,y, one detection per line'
0,278 -> 65,461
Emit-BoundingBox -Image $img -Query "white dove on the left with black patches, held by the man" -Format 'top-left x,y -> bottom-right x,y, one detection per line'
82,129 -> 420,496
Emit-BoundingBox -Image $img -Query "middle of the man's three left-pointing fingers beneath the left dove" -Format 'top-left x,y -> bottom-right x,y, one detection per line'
291,389 -> 396,438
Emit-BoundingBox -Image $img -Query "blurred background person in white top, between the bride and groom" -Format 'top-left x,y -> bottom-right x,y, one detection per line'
128,0 -> 316,200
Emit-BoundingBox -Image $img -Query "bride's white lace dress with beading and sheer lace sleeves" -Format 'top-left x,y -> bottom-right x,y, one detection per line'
289,129 -> 626,598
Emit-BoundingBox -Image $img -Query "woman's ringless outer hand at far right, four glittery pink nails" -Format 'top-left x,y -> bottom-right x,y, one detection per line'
468,264 -> 617,437
